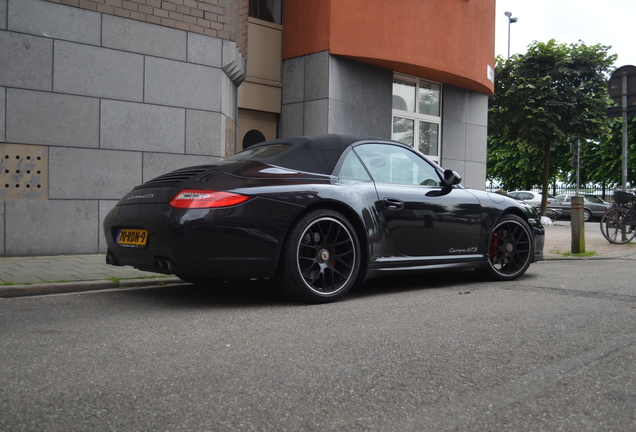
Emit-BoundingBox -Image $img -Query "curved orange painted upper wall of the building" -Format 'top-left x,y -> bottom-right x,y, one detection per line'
283,0 -> 495,94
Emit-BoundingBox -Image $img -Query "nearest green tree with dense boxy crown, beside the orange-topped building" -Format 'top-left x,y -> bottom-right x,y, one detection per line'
488,40 -> 616,213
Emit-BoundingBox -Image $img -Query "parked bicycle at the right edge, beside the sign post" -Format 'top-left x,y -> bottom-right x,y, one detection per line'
600,190 -> 636,244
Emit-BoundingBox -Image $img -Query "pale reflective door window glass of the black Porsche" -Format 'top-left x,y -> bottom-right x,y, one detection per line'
354,144 -> 441,186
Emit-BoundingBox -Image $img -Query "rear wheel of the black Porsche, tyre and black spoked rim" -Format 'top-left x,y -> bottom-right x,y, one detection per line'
274,209 -> 360,303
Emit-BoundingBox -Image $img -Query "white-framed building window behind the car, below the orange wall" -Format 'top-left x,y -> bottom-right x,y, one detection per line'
392,75 -> 442,162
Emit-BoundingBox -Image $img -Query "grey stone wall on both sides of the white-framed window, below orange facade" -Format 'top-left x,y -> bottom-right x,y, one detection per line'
281,51 -> 488,189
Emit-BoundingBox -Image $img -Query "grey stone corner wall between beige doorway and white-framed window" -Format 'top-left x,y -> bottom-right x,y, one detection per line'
281,51 -> 393,138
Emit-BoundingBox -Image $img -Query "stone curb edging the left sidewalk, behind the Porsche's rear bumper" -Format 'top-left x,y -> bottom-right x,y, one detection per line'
0,277 -> 185,298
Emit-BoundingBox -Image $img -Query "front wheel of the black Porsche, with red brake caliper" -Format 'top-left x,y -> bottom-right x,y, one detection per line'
477,214 -> 534,281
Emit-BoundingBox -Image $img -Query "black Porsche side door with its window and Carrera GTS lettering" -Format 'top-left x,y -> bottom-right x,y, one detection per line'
354,143 -> 481,257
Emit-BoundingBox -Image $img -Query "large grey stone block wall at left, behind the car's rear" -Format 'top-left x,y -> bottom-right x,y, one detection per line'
0,0 -> 245,256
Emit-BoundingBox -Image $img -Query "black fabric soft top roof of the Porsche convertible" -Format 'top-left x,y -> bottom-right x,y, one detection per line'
226,134 -> 387,175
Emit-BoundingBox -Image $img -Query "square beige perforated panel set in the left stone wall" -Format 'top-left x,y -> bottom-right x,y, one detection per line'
0,144 -> 49,199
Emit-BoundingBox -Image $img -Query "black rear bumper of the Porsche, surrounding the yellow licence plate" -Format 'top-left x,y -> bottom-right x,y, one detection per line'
104,199 -> 297,279
